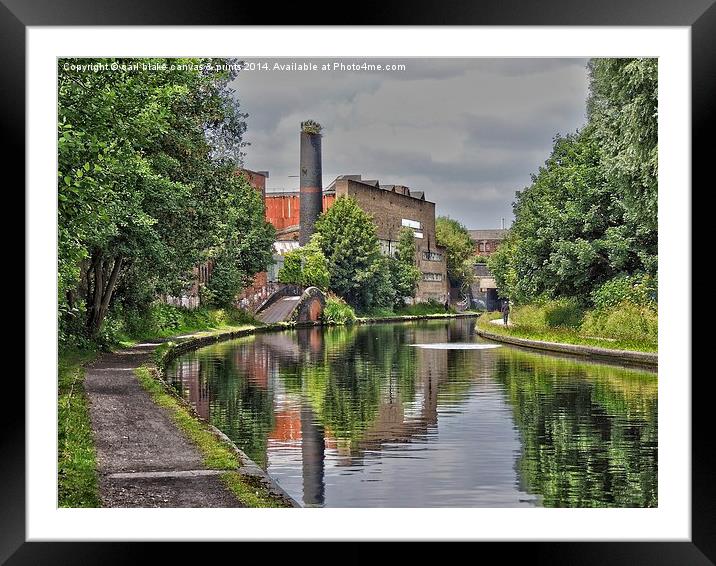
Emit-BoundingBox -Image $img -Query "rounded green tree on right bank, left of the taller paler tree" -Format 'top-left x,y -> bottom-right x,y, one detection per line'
490,130 -> 618,301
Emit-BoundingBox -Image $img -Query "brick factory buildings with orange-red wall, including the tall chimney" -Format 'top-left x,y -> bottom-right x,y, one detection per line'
173,121 -> 449,312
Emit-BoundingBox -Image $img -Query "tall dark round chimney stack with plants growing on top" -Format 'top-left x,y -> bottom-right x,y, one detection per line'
298,120 -> 323,246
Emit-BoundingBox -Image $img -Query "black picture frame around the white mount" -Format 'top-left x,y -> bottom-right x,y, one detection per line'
9,0 -> 704,566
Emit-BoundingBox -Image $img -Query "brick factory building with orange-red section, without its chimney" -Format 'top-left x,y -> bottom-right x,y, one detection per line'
266,175 -> 449,302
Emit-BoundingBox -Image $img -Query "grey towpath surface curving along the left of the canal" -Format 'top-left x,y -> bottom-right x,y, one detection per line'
85,343 -> 242,507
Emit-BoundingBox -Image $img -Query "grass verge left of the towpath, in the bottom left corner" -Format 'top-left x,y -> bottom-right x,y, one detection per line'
57,350 -> 101,507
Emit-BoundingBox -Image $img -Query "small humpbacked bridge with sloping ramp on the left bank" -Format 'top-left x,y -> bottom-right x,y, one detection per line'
255,285 -> 326,324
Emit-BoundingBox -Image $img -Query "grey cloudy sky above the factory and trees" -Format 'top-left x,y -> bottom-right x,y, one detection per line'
232,58 -> 588,228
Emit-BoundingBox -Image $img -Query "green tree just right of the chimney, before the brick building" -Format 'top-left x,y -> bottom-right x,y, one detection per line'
316,196 -> 395,311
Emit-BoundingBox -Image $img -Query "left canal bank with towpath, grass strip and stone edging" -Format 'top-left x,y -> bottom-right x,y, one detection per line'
79,314 -> 470,507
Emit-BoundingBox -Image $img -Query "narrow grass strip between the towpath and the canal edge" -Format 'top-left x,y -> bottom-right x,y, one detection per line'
135,366 -> 287,507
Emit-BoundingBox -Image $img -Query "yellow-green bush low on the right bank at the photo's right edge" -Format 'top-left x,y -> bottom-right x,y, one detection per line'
581,301 -> 659,343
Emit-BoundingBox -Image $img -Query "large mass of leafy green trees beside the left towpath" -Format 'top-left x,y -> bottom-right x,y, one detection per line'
58,59 -> 271,337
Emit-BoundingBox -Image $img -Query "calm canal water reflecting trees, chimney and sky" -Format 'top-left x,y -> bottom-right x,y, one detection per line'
168,319 -> 658,507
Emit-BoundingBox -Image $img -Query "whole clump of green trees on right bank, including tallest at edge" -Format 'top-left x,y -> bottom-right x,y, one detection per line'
489,59 -> 657,302
